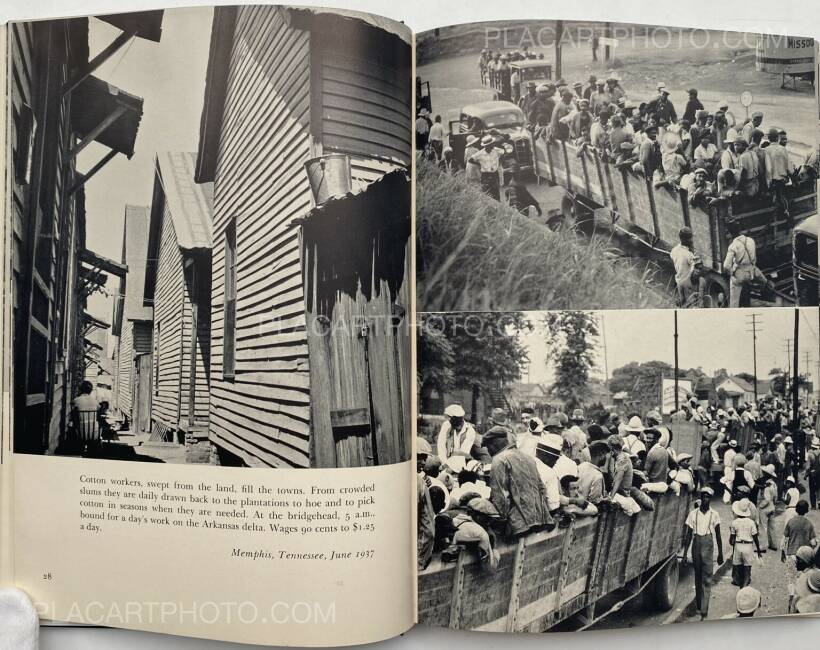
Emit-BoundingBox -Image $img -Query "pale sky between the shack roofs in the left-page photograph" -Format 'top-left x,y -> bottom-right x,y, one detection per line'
78,8 -> 213,336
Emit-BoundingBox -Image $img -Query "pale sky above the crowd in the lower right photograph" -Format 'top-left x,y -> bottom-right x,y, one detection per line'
522,307 -> 820,386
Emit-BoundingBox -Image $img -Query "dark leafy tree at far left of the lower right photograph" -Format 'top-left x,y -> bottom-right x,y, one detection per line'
418,312 -> 532,420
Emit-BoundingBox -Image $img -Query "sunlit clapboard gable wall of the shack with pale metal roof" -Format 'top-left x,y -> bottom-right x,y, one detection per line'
151,197 -> 190,433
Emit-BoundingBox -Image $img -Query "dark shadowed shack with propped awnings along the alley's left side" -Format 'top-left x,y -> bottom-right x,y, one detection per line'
3,11 -> 162,453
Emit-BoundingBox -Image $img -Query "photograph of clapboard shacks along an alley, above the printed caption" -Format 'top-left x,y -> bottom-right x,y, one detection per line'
4,6 -> 412,468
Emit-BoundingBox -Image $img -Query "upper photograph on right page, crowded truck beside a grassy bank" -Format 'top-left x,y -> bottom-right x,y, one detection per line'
416,20 -> 819,311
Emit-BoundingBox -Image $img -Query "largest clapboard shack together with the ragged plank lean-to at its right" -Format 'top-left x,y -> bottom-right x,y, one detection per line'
196,6 -> 412,468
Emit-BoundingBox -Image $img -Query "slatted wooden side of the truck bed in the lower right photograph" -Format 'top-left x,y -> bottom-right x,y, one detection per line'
418,493 -> 690,632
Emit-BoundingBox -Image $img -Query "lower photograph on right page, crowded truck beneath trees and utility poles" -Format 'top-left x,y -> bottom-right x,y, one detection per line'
416,308 -> 820,638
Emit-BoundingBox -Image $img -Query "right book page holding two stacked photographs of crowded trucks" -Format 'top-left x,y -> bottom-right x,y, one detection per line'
415,20 -> 820,632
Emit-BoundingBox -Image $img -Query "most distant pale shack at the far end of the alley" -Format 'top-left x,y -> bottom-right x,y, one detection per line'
111,205 -> 153,433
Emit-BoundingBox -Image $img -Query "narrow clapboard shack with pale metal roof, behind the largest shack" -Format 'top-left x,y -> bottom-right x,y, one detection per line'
144,152 -> 213,462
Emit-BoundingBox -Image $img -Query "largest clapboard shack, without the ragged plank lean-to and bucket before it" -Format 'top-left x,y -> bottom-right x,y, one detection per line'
197,6 -> 412,467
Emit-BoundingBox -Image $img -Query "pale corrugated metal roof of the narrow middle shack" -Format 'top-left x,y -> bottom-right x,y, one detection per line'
157,151 -> 214,250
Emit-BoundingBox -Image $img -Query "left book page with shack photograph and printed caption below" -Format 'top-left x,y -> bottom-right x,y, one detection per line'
0,6 -> 414,646
